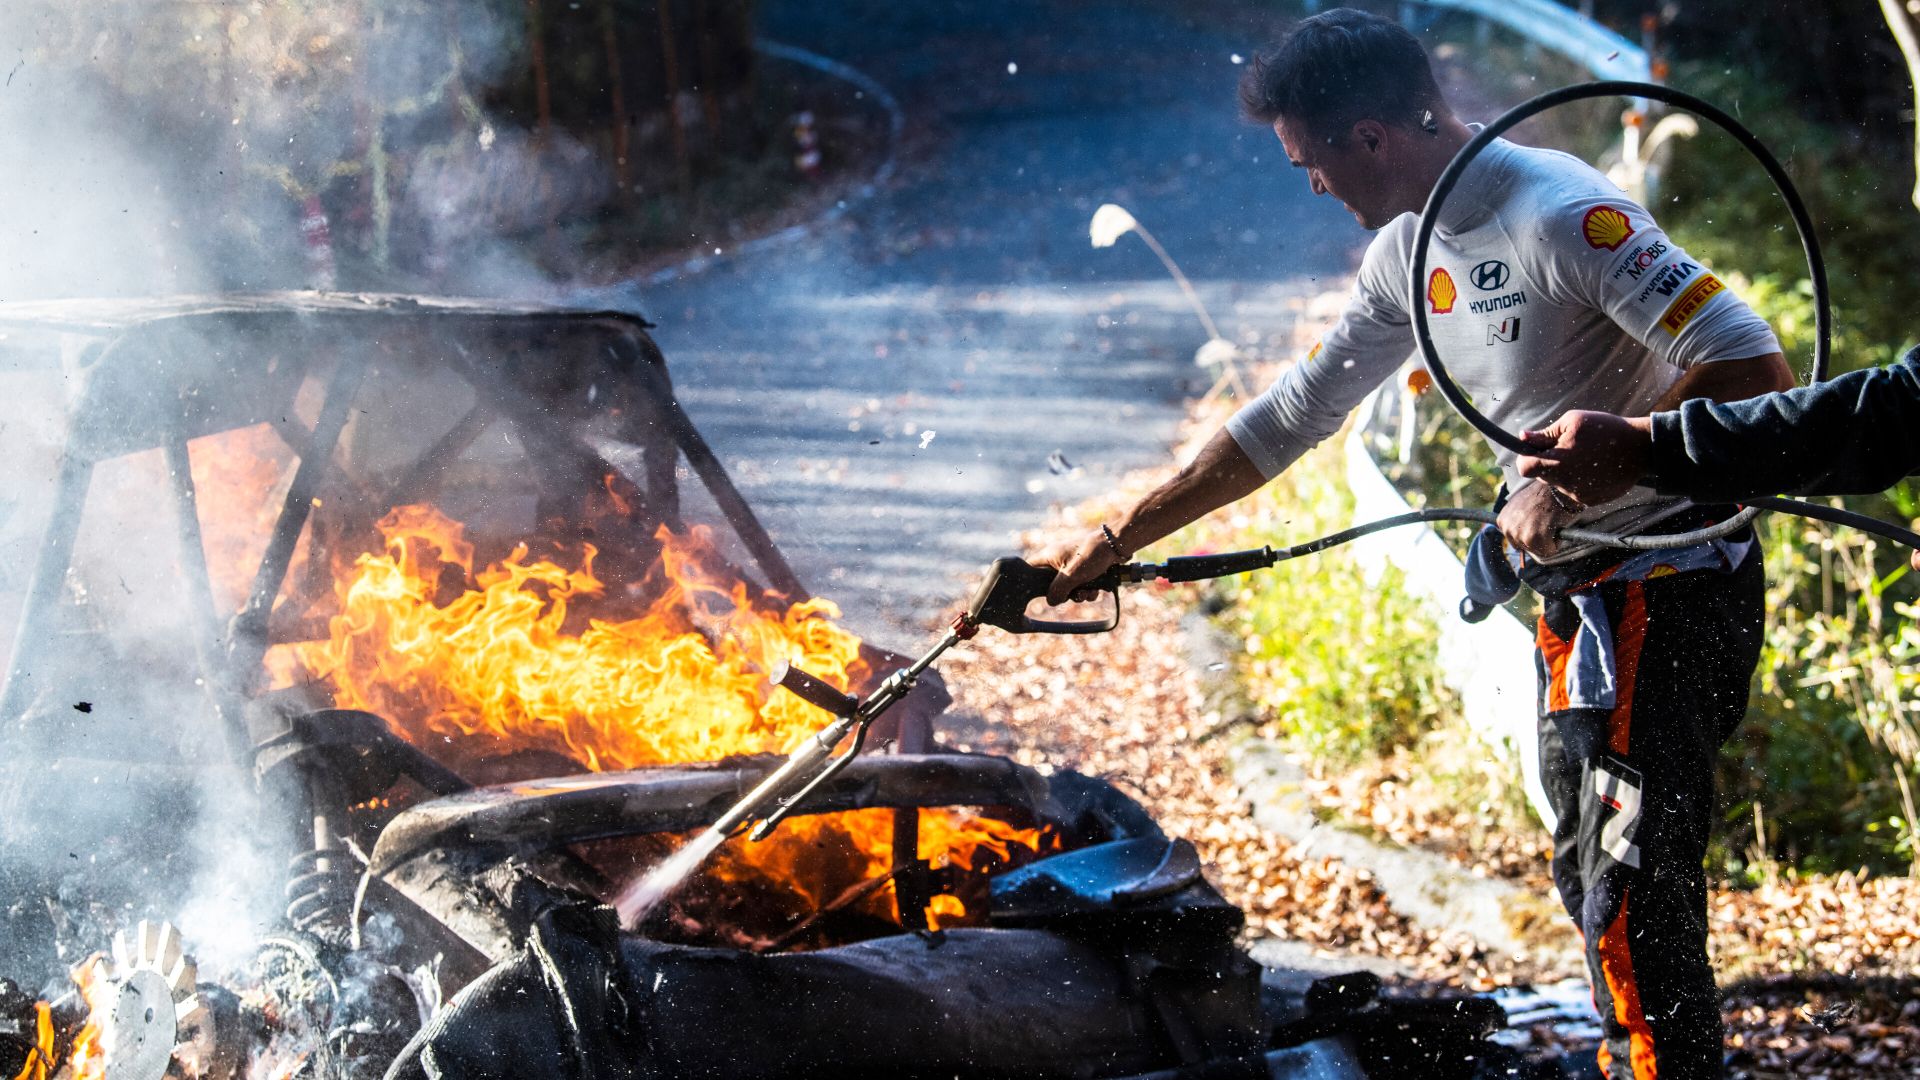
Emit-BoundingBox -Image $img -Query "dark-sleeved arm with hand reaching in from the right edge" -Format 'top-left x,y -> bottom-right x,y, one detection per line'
1519,350 -> 1920,502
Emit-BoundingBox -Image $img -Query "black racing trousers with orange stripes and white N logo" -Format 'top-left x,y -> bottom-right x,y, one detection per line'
1534,546 -> 1766,1080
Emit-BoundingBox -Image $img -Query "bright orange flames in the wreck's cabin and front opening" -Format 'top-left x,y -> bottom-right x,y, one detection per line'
276,505 -> 1050,917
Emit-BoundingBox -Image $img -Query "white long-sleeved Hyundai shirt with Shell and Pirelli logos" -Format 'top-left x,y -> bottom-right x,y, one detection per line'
1227,138 -> 1780,563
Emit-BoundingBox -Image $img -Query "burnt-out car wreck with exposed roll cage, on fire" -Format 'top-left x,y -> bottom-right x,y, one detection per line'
0,294 -> 1501,1080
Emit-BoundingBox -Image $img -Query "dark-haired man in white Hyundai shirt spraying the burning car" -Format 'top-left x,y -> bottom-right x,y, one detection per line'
1039,10 -> 1793,1078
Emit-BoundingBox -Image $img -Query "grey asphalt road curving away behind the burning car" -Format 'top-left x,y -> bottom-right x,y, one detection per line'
602,0 -> 1365,648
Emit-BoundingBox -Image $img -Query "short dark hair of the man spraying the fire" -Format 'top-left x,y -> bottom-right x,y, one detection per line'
1240,8 -> 1444,142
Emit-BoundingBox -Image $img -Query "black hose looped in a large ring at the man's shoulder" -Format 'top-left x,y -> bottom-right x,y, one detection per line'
1405,79 -> 1920,552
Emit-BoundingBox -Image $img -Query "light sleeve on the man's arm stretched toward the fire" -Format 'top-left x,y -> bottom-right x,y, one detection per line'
1227,219 -> 1413,480
